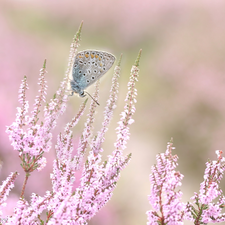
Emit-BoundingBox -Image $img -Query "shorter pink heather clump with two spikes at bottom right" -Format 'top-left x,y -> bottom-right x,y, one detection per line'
147,141 -> 225,225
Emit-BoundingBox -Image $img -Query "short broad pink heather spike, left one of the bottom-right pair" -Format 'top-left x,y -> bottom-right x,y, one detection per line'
147,142 -> 185,225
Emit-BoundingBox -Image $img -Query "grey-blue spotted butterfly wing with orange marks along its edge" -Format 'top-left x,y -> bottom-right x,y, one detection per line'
72,50 -> 115,90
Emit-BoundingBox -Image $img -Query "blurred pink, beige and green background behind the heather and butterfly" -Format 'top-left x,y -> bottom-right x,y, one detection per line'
0,0 -> 225,225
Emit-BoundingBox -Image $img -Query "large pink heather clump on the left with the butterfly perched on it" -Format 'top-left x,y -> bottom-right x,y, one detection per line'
0,21 -> 141,224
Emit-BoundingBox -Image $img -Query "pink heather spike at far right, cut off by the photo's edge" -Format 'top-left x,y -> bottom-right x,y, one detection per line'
186,151 -> 225,225
